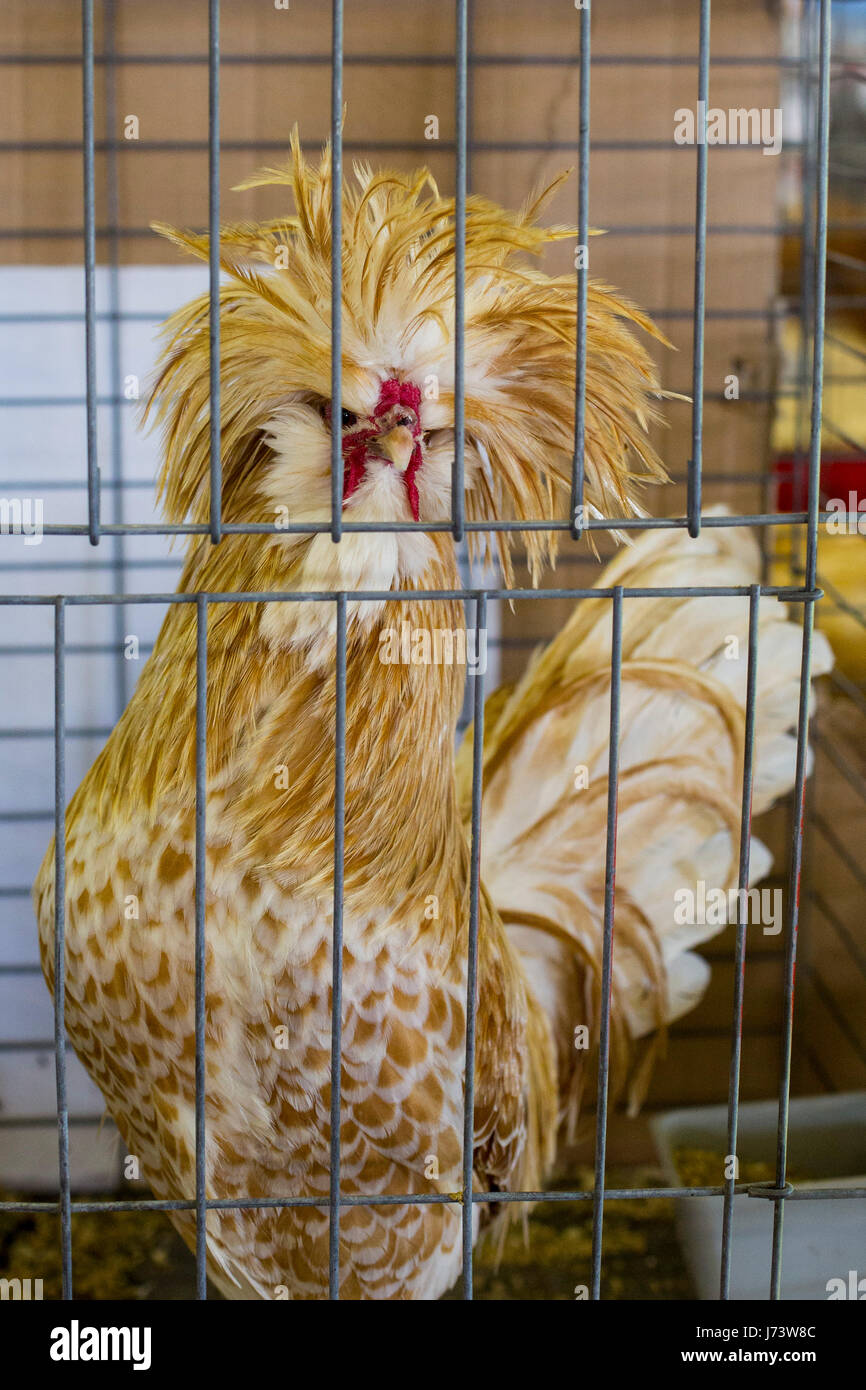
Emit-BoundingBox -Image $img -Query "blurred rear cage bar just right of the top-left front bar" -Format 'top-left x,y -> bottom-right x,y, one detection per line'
103,0 -> 129,719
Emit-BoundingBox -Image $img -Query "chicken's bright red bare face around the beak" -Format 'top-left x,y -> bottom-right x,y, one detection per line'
333,377 -> 421,521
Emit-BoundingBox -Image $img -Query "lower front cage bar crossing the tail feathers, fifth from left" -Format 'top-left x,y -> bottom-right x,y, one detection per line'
589,584 -> 623,1300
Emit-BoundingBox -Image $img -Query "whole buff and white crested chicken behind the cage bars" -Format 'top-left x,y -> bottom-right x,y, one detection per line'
35,136 -> 828,1298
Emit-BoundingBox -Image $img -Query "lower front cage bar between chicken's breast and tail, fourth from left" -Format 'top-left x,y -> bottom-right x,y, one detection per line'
463,594 -> 487,1300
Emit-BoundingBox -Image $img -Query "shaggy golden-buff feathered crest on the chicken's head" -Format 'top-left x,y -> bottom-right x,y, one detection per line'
152,129 -> 666,580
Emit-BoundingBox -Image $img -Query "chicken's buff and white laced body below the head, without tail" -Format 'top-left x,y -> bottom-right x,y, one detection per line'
38,547 -> 555,1298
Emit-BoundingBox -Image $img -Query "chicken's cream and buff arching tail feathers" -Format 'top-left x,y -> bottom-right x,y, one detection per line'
459,511 -> 833,1118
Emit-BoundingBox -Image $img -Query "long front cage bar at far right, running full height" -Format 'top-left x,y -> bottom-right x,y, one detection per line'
770,0 -> 830,1301
